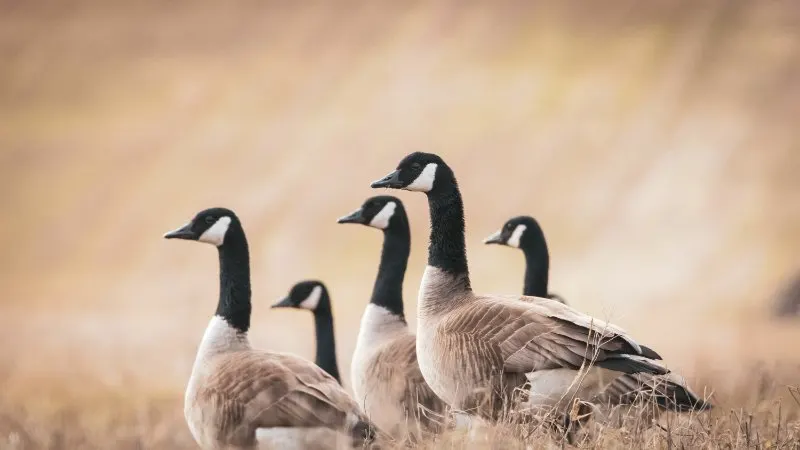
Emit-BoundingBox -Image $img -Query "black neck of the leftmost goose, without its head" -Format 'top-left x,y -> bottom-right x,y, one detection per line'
216,224 -> 252,333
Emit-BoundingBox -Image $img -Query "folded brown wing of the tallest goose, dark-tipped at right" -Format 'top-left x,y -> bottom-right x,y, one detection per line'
439,296 -> 656,373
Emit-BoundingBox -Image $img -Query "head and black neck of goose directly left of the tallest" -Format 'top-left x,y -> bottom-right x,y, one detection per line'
337,195 -> 411,323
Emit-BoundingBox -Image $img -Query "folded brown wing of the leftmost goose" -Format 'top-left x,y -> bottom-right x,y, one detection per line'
195,351 -> 357,428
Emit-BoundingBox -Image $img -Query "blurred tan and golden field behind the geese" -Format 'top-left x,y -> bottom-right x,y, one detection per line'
0,0 -> 800,448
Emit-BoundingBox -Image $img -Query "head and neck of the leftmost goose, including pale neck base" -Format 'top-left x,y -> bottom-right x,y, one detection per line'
164,208 -> 252,351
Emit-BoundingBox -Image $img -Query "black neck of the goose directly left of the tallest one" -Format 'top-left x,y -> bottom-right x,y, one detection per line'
370,216 -> 411,321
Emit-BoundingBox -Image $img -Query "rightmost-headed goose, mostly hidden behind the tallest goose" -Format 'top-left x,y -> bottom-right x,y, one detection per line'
484,216 -> 711,411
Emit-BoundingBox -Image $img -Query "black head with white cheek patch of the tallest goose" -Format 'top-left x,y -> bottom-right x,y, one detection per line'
371,152 -> 454,193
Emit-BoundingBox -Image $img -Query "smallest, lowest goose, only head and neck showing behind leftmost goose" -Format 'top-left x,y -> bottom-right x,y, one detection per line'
272,280 -> 342,384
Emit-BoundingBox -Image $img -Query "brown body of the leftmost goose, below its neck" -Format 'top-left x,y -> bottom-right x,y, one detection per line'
184,326 -> 365,448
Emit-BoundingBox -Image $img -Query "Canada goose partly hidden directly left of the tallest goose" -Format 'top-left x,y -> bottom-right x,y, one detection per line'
338,196 -> 446,439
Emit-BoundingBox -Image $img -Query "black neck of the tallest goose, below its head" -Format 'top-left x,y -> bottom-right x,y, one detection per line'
428,175 -> 470,289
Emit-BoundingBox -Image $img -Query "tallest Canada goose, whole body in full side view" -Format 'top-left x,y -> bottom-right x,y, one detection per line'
372,152 -> 688,419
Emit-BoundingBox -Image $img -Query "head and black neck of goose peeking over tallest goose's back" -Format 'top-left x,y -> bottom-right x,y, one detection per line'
483,216 -> 550,297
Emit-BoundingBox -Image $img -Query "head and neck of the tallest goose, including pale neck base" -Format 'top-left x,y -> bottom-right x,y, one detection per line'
372,152 -> 472,307
